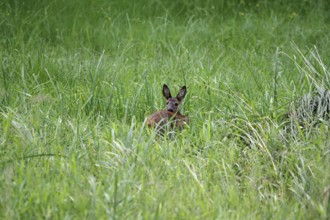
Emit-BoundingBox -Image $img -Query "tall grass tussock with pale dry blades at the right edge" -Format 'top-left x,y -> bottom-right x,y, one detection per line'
282,45 -> 330,138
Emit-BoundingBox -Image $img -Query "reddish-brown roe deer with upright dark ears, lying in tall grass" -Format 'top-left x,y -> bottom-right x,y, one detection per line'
147,84 -> 189,132
